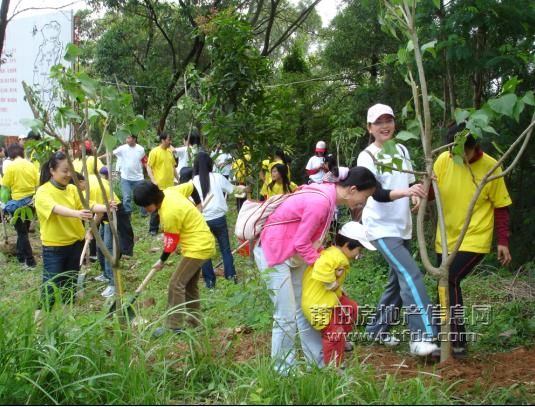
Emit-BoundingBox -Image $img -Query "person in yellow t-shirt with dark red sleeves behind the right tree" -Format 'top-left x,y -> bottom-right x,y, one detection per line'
433,123 -> 512,357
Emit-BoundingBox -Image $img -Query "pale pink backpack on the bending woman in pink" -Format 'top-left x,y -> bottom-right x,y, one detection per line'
234,190 -> 329,240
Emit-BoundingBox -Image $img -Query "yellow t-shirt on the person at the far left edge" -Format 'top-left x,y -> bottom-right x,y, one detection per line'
2,157 -> 39,200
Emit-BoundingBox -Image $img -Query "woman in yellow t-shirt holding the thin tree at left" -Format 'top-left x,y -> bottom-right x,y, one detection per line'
35,151 -> 116,309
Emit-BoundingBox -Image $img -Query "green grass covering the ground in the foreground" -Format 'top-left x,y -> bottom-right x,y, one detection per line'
0,203 -> 535,404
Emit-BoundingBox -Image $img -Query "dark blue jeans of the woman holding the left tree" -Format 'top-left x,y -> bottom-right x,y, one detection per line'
39,240 -> 84,309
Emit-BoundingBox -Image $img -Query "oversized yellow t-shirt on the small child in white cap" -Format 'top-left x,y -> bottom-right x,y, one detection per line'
301,246 -> 349,331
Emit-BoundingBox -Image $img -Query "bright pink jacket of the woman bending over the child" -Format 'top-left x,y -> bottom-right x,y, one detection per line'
260,183 -> 336,267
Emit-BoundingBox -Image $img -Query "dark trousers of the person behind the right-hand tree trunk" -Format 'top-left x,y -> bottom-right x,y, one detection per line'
437,252 -> 485,348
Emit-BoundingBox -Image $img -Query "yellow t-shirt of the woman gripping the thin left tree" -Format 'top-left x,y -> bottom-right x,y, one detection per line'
35,182 -> 85,246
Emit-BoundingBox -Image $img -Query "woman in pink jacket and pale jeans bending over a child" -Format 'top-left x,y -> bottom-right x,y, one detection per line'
254,167 -> 382,375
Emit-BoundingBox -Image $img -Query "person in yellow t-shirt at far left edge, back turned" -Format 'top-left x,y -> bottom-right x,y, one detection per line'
2,143 -> 39,268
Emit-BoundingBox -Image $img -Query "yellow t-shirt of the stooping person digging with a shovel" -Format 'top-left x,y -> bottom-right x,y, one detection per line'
158,187 -> 215,259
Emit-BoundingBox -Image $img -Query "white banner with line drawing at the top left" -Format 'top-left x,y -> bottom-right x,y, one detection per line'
0,11 -> 73,136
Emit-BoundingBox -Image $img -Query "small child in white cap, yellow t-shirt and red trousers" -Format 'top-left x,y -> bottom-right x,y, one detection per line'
301,221 -> 376,366
